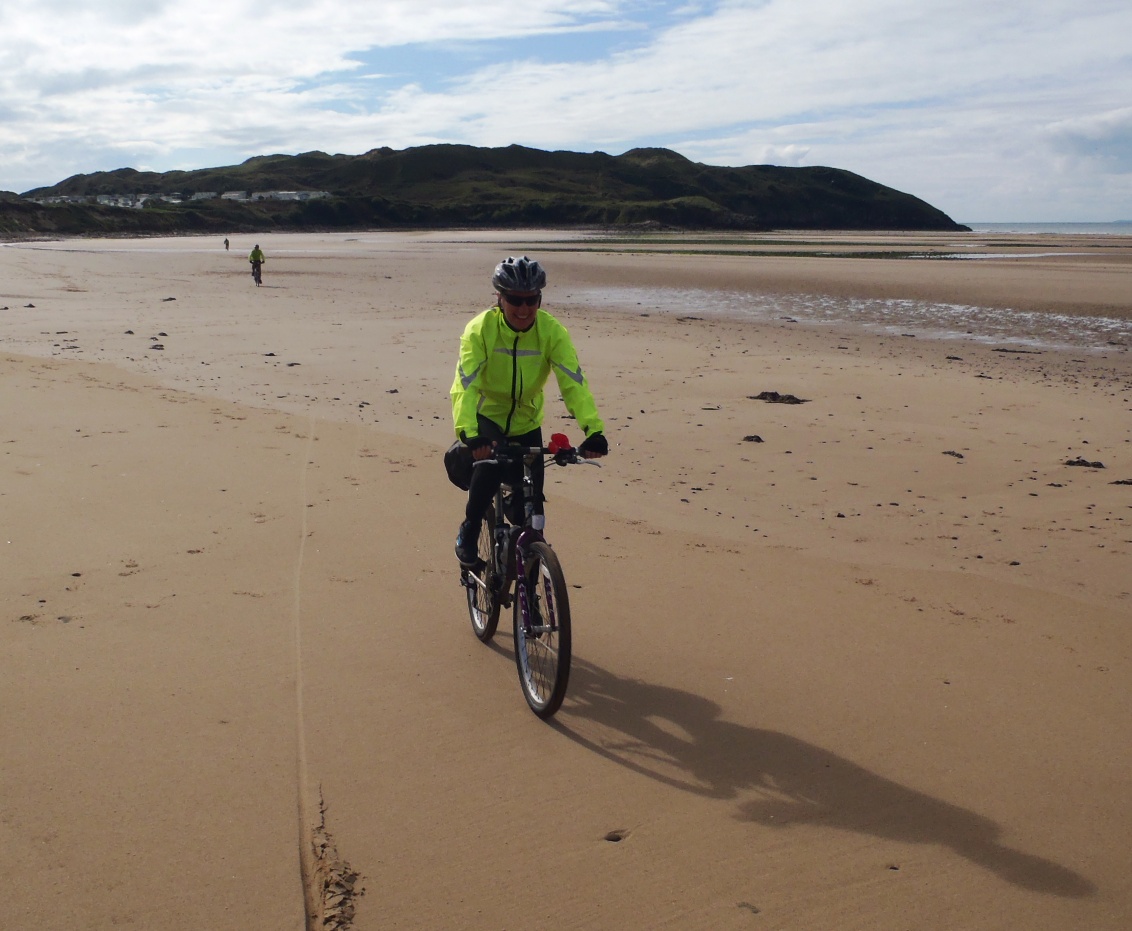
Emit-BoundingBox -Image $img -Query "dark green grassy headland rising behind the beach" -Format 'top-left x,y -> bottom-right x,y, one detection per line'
0,145 -> 964,233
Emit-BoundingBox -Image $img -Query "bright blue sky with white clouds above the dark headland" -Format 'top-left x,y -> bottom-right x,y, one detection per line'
0,0 -> 1132,222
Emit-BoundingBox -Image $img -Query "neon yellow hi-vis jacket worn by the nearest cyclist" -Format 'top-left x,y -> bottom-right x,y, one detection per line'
452,307 -> 604,441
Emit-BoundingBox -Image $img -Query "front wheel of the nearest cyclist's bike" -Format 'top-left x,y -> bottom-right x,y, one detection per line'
513,543 -> 571,718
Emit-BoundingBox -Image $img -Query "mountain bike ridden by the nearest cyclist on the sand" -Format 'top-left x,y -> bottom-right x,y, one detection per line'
460,434 -> 599,719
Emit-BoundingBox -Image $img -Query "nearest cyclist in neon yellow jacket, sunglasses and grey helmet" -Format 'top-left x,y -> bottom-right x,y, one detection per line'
452,256 -> 609,566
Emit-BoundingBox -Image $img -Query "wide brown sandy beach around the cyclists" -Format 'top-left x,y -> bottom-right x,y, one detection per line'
0,231 -> 1132,931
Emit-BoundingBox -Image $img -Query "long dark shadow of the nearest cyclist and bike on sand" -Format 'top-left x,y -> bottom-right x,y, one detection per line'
552,657 -> 1097,898
